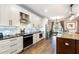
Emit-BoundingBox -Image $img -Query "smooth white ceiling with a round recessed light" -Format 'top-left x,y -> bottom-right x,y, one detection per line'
18,4 -> 79,17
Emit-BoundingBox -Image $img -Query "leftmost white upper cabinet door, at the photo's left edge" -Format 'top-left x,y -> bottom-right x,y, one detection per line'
0,4 -> 11,26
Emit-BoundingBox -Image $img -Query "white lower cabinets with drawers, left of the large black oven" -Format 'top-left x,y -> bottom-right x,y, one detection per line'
0,36 -> 23,54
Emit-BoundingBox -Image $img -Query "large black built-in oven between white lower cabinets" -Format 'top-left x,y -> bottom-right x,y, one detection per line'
23,34 -> 33,48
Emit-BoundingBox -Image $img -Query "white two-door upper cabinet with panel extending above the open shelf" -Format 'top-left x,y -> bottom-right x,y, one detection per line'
0,4 -> 29,26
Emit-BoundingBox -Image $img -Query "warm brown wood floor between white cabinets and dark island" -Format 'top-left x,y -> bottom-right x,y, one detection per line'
21,39 -> 56,54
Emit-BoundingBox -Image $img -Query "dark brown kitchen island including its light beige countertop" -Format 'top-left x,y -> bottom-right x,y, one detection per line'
56,33 -> 79,54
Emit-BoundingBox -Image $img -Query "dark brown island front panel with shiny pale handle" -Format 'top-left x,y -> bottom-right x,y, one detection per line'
57,39 -> 75,54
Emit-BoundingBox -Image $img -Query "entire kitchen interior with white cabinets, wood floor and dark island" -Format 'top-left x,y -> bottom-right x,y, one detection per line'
0,4 -> 79,54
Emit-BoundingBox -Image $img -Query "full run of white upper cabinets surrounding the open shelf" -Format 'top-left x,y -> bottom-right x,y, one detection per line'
0,4 -> 41,26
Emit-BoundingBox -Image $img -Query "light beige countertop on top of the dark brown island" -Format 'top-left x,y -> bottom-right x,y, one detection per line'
57,33 -> 79,40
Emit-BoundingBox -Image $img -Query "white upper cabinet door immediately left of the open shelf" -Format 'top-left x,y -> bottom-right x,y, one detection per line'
11,5 -> 20,26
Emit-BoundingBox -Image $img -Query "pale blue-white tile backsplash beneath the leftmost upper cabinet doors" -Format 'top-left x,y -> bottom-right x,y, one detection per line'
0,26 -> 18,36
